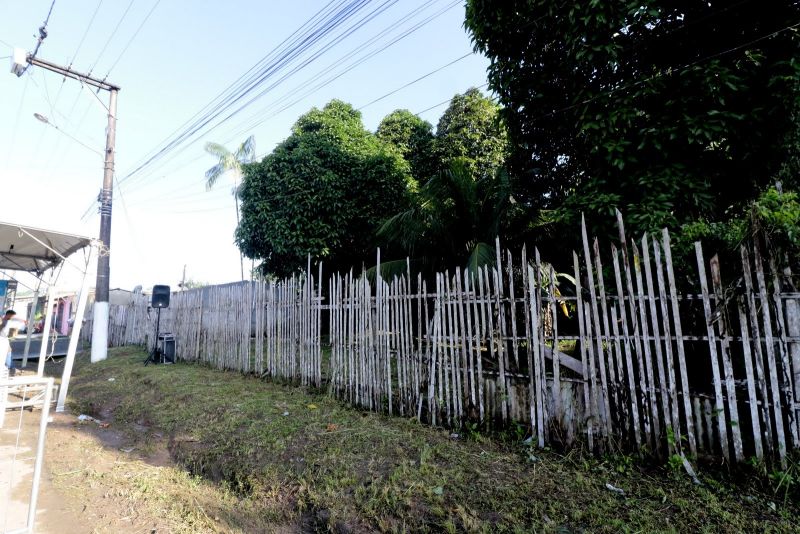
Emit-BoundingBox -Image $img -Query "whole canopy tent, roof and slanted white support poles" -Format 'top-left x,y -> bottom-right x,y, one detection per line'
0,222 -> 98,412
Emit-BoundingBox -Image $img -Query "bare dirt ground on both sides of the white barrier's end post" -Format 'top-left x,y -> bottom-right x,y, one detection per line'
0,372 -> 247,534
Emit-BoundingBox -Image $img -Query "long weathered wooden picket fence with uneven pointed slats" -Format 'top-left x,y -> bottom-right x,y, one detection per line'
90,215 -> 800,463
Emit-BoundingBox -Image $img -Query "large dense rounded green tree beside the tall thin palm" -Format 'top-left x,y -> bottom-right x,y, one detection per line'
236,100 -> 414,276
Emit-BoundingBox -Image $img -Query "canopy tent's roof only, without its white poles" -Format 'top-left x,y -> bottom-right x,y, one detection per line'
0,222 -> 92,274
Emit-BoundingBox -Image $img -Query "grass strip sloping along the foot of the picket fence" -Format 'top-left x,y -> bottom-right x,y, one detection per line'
57,348 -> 798,532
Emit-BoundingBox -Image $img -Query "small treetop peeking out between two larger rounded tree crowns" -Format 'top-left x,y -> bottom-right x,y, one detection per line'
375,109 -> 436,182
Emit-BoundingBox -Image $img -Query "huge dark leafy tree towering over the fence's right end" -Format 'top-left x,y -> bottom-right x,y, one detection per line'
466,0 -> 800,241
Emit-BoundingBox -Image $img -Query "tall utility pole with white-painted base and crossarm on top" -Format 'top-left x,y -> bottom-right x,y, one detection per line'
11,53 -> 119,362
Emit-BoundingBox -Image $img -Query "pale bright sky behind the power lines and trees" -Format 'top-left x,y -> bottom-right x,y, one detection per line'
0,0 -> 488,296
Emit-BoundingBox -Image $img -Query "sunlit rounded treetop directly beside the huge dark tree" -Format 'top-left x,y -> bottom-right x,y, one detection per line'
434,87 -> 507,177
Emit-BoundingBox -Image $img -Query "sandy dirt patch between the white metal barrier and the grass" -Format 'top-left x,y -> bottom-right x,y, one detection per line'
32,413 -> 268,534
